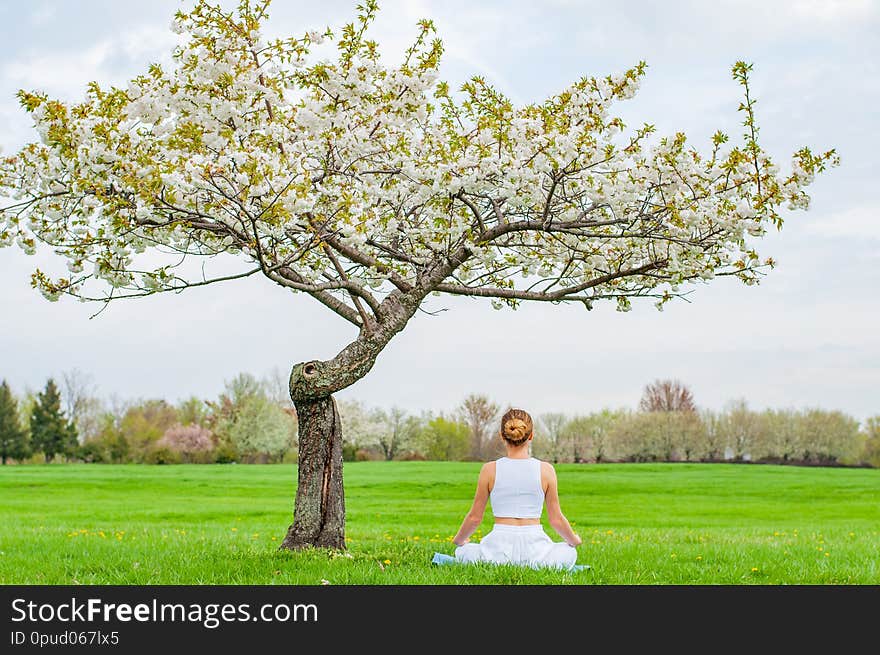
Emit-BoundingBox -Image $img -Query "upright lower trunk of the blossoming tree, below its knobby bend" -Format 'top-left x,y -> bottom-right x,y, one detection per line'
281,396 -> 345,550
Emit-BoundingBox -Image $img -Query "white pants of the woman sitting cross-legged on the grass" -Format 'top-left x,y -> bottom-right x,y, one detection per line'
455,523 -> 577,569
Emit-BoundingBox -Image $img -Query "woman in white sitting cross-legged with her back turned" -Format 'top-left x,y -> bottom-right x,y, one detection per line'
452,409 -> 581,569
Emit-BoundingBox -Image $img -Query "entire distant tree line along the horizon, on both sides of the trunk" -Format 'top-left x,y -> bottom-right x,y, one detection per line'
0,371 -> 880,467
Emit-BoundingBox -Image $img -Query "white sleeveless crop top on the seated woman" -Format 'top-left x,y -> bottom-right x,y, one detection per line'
489,457 -> 544,519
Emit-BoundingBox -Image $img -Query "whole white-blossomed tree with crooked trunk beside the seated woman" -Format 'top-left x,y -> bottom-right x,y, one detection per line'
0,0 -> 836,549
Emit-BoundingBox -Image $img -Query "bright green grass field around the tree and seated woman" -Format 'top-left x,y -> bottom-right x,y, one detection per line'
0,462 -> 880,585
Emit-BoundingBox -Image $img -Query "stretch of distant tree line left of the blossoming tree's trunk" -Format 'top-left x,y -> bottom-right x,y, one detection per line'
0,371 -> 296,464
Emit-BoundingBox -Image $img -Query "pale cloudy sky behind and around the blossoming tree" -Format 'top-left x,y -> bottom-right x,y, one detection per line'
0,0 -> 880,420
